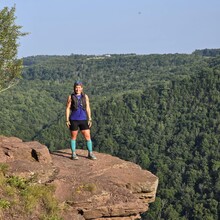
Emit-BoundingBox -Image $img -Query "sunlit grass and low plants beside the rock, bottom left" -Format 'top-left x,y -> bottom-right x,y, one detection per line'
0,164 -> 62,220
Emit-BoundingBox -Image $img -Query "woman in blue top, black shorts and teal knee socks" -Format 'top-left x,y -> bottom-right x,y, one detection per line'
66,81 -> 96,160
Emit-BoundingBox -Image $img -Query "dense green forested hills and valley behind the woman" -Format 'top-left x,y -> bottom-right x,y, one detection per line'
0,50 -> 220,220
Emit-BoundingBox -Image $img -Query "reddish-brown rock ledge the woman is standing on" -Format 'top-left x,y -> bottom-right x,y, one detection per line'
0,137 -> 158,220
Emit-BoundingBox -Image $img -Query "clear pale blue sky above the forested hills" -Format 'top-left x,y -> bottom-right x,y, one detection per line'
0,0 -> 220,58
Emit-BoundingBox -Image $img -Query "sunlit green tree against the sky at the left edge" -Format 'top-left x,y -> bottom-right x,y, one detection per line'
0,7 -> 27,92
